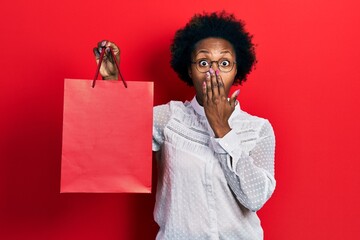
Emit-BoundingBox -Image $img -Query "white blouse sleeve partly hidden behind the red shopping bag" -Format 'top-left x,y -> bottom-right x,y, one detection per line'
152,103 -> 170,152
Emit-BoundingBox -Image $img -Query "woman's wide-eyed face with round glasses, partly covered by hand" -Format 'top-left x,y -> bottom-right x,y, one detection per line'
189,38 -> 237,105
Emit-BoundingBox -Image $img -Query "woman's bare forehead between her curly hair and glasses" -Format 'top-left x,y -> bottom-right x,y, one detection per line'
193,38 -> 234,55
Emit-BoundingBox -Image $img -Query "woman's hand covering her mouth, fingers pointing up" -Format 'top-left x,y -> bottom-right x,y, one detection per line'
203,68 -> 239,138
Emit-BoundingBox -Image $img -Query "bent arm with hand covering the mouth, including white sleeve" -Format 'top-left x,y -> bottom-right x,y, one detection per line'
203,69 -> 276,211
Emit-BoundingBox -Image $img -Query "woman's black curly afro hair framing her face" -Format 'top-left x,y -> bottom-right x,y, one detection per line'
170,11 -> 256,86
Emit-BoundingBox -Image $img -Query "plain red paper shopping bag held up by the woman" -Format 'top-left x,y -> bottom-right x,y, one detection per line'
60,45 -> 153,193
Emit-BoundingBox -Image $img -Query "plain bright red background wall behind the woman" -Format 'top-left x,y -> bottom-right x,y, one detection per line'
0,0 -> 360,240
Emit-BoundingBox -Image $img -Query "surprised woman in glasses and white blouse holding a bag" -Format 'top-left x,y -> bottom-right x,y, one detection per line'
94,12 -> 276,240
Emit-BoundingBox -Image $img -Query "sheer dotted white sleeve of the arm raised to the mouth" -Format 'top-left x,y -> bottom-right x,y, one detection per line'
211,120 -> 276,211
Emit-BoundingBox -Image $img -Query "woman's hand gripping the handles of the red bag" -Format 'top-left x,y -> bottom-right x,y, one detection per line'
93,40 -> 120,80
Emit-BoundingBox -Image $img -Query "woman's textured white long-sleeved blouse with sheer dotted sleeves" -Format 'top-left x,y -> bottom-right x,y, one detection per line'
153,98 -> 276,240
